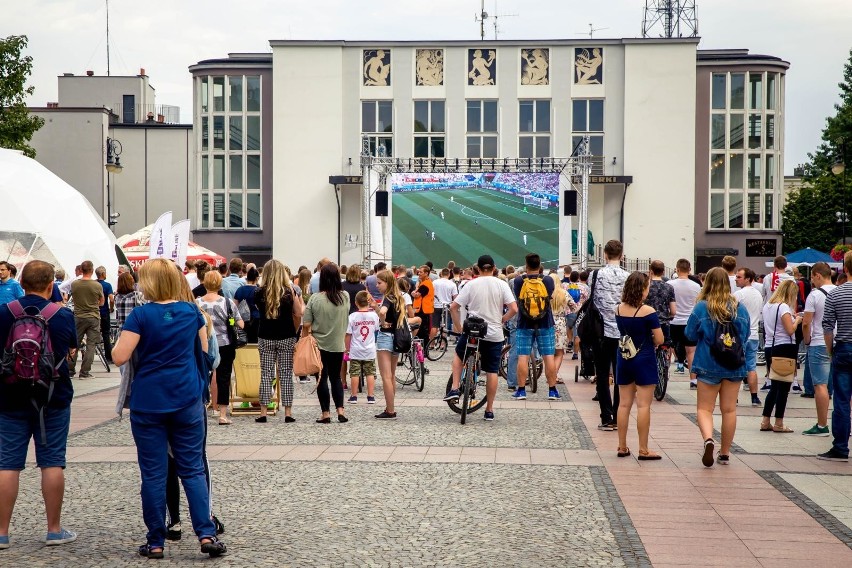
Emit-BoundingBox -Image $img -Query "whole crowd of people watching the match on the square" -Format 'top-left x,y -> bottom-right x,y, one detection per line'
0,241 -> 852,558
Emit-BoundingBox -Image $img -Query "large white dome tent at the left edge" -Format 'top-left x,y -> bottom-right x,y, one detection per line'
0,148 -> 118,283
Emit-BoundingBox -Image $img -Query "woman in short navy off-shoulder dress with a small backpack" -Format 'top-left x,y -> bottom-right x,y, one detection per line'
615,272 -> 663,460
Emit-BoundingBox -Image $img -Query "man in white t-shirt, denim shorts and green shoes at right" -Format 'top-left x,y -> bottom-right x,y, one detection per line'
802,262 -> 837,437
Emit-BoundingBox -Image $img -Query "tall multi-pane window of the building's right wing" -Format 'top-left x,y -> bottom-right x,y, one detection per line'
709,72 -> 780,229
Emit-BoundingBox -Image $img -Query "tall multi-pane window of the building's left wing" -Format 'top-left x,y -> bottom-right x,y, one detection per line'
198,75 -> 262,230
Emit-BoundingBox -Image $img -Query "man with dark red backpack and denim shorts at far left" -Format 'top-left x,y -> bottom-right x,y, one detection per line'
0,260 -> 77,549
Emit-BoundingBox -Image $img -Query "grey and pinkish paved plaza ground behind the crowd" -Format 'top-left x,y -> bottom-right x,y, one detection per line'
5,355 -> 852,567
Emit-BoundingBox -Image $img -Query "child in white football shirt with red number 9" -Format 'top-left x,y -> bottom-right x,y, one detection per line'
346,290 -> 379,404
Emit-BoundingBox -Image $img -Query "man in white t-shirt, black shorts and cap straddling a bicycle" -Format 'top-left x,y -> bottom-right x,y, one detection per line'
444,254 -> 518,421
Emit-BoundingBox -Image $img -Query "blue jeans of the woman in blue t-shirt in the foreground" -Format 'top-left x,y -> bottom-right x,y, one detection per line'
130,399 -> 216,548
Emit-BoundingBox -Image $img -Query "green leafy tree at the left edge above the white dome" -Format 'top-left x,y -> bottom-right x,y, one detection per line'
0,36 -> 44,158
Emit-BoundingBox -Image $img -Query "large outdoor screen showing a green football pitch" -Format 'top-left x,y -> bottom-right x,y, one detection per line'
390,173 -> 559,267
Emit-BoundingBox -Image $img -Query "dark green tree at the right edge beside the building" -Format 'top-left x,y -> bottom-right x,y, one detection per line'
781,50 -> 852,252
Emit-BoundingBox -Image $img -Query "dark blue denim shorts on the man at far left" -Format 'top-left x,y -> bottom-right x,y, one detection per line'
0,406 -> 71,471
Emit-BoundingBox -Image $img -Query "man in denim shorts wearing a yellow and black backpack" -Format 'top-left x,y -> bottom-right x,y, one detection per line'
512,253 -> 562,400
